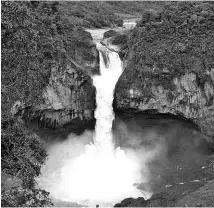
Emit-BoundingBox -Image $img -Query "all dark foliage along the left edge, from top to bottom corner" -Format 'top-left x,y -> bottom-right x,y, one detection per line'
1,1 -> 64,206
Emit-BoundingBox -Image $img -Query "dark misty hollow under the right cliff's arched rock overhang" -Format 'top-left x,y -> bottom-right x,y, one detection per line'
113,110 -> 213,196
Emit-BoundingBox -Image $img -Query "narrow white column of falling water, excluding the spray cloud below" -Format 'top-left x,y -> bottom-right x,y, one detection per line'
93,43 -> 122,151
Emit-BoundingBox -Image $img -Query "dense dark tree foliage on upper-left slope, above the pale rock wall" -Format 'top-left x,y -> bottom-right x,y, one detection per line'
1,2 -> 65,122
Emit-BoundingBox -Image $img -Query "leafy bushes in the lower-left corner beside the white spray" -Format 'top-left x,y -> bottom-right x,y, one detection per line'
1,124 -> 51,207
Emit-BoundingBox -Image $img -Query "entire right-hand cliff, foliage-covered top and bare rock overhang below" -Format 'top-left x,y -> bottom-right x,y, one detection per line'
114,3 -> 214,142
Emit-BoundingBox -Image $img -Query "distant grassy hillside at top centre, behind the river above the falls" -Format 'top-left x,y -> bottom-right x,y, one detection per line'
59,1 -> 164,28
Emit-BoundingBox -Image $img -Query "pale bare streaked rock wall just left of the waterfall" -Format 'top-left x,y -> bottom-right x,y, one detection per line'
39,58 -> 95,127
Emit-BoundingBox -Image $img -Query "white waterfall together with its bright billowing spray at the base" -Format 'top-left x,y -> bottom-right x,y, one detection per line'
36,44 -> 151,206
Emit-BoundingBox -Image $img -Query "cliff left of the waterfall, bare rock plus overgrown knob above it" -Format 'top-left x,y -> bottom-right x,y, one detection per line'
39,29 -> 99,127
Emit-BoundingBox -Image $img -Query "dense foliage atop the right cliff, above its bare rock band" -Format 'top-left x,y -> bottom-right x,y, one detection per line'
129,2 -> 214,76
